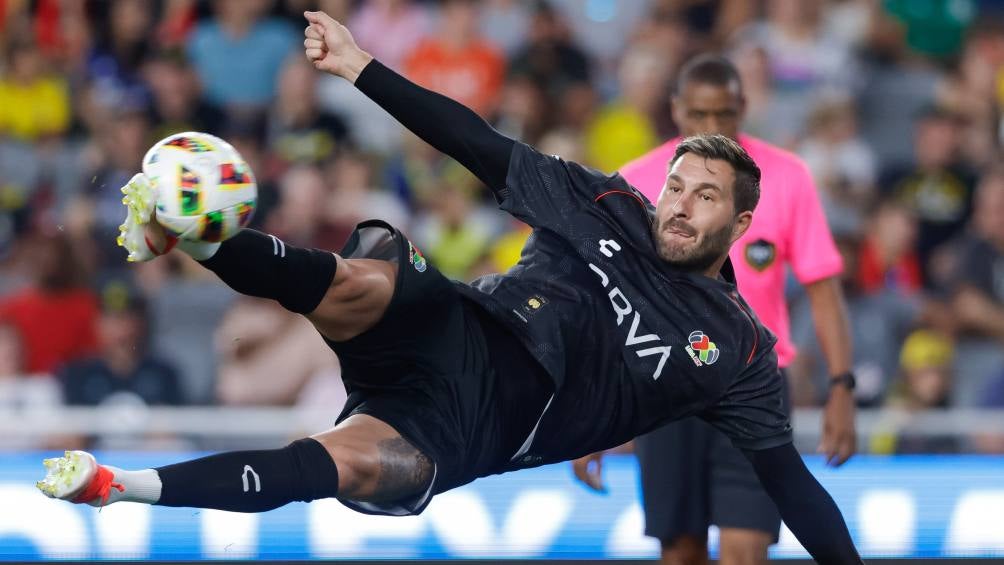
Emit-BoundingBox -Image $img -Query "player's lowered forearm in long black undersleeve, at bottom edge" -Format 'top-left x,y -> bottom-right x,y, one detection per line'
743,444 -> 862,565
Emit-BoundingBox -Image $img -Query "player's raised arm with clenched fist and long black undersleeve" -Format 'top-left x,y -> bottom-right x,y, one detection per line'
303,12 -> 514,193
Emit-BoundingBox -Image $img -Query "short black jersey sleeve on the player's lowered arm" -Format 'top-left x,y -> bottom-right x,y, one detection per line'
700,347 -> 792,451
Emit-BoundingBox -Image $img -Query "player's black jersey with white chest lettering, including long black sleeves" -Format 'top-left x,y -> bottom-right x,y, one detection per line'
355,60 -> 860,565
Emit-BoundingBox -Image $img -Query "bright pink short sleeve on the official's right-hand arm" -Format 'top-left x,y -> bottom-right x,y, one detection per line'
788,162 -> 843,284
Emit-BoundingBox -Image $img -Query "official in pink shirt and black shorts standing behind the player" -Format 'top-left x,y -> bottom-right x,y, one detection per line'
574,55 -> 855,565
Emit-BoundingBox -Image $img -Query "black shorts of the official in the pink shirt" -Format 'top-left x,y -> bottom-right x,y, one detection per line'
635,371 -> 787,545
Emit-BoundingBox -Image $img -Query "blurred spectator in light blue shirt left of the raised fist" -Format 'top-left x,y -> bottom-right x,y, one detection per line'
188,0 -> 301,114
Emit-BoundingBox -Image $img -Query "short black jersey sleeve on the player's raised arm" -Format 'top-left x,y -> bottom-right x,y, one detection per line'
496,142 -> 648,228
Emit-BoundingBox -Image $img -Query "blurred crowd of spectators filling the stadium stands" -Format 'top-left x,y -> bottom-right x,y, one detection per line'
0,0 -> 1004,453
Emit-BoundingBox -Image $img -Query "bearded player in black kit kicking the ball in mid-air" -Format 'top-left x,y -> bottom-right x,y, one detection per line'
33,12 -> 860,564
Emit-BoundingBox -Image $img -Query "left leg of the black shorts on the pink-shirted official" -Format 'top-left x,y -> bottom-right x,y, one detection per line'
635,417 -> 712,544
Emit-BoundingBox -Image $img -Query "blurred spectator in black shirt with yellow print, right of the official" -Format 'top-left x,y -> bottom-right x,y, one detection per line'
880,106 -> 974,281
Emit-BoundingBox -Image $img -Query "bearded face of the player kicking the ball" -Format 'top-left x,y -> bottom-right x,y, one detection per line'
652,154 -> 738,272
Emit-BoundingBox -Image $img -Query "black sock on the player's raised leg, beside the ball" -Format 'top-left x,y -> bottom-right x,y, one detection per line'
200,229 -> 337,314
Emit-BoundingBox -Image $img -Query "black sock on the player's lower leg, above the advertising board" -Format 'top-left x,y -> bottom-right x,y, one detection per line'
156,438 -> 338,512
